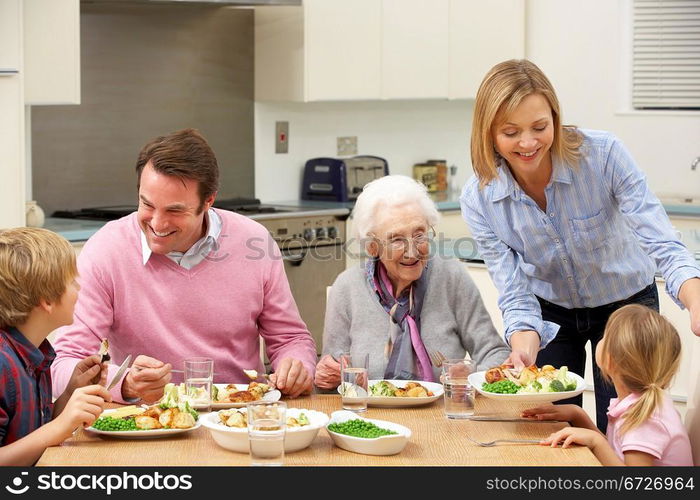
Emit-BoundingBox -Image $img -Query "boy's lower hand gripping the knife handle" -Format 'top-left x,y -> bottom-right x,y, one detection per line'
52,385 -> 112,443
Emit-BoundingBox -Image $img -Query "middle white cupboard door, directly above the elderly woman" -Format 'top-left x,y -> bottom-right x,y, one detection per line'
382,0 -> 448,99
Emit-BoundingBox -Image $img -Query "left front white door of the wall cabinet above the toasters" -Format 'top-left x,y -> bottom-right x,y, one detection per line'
304,0 -> 382,101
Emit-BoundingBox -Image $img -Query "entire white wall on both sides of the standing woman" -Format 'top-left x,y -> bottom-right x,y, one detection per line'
255,0 -> 700,201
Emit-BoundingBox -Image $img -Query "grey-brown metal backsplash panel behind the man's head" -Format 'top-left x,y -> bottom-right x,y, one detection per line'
31,3 -> 254,215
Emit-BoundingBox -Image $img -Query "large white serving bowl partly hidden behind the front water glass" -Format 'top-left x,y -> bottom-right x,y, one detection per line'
200,408 -> 328,453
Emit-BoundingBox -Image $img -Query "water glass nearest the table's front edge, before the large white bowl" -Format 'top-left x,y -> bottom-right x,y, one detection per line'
246,401 -> 287,465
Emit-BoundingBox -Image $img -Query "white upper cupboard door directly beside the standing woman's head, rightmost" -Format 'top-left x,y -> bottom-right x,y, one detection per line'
449,0 -> 525,99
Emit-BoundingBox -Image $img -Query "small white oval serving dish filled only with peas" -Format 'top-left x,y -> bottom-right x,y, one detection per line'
326,410 -> 411,455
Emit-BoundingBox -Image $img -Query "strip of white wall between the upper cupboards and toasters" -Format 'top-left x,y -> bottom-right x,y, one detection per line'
255,101 -> 473,202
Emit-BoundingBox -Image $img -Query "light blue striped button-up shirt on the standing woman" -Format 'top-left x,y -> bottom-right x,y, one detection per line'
460,130 -> 700,346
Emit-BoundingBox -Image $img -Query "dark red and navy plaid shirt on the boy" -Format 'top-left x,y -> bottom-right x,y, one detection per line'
0,328 -> 56,446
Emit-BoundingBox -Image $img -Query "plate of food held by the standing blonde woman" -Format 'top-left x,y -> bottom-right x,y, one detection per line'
469,365 -> 586,403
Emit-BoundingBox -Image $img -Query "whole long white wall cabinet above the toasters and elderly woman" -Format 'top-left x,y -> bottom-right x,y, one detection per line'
255,0 -> 525,101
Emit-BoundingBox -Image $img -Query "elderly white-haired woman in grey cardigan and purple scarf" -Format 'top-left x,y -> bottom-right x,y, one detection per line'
315,175 -> 509,389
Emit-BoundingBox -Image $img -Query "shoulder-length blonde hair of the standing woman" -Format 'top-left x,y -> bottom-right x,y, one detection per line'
471,59 -> 583,187
